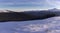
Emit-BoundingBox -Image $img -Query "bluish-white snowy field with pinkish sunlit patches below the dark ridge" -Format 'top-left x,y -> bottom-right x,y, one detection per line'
0,16 -> 60,33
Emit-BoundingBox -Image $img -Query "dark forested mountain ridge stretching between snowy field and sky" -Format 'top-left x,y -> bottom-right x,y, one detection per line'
0,10 -> 60,22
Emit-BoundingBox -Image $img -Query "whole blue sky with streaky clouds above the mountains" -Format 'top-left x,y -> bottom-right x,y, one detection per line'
0,0 -> 60,10
